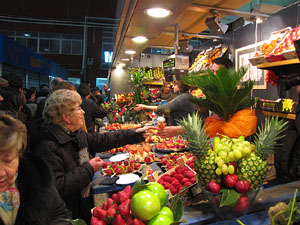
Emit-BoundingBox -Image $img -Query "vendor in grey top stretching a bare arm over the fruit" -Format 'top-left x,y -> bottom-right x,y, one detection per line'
134,80 -> 196,126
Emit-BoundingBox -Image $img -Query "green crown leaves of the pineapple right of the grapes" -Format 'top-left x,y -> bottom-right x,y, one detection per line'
254,117 -> 288,160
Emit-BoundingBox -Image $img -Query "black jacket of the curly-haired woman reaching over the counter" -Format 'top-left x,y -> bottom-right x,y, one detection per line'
30,122 -> 144,221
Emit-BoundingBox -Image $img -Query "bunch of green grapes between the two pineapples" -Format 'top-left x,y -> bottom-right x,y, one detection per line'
213,136 -> 255,175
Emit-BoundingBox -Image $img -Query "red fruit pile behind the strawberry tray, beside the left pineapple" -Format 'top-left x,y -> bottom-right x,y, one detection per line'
160,153 -> 196,171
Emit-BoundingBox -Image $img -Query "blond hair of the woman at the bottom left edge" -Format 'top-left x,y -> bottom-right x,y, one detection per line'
0,112 -> 27,156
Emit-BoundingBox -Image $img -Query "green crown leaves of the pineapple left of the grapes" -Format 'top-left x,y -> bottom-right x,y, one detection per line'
178,112 -> 209,158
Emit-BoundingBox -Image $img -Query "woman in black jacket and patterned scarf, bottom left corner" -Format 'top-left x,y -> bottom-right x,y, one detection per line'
0,112 -> 71,225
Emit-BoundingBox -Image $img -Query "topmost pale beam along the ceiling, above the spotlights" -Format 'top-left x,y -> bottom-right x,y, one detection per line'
188,4 -> 269,20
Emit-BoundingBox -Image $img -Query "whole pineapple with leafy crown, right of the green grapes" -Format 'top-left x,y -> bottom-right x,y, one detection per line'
237,117 -> 287,189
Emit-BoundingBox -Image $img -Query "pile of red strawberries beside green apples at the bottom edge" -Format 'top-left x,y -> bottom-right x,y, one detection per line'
91,185 -> 144,225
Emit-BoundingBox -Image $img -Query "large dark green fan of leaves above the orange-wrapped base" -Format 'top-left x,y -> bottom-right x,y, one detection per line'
181,66 -> 254,121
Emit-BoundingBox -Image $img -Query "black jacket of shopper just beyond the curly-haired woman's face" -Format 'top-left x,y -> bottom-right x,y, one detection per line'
81,98 -> 107,133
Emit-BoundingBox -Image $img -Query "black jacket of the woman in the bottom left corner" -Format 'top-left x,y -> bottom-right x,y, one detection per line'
0,153 -> 71,225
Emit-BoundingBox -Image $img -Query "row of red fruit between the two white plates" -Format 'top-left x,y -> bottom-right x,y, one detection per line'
102,160 -> 142,176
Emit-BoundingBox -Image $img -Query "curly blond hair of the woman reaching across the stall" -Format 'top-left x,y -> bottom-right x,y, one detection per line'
43,89 -> 82,125
